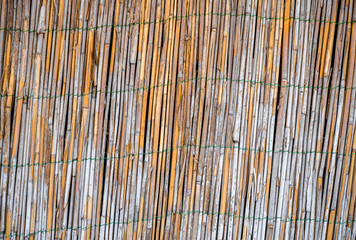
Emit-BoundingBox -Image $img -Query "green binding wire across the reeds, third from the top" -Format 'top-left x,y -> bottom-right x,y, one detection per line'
0,144 -> 356,168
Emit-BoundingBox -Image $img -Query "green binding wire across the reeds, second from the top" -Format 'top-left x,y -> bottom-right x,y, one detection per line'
0,77 -> 356,101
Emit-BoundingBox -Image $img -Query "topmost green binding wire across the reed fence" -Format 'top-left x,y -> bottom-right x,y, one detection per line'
0,12 -> 355,33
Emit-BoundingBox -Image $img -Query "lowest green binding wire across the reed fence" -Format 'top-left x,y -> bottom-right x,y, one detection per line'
5,211 -> 356,238
